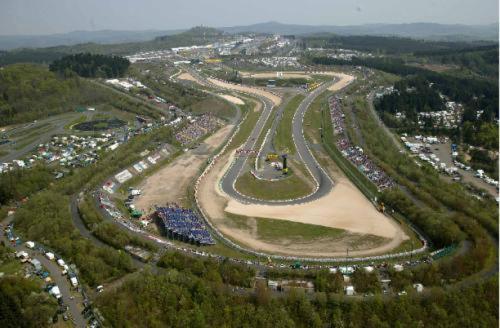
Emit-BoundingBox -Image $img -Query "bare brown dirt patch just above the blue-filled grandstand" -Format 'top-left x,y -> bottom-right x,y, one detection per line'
134,125 -> 233,214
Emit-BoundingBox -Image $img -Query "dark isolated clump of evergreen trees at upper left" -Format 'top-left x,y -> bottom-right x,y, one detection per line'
49,53 -> 130,78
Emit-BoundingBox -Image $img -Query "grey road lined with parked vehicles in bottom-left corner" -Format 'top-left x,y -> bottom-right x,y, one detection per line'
0,216 -> 87,327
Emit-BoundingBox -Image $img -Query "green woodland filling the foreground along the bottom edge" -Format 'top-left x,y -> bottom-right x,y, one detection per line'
96,270 -> 498,328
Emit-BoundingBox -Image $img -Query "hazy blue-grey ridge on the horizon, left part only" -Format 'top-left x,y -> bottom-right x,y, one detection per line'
0,30 -> 183,50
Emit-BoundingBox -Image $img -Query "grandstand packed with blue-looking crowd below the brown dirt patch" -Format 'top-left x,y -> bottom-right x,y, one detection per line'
155,204 -> 215,245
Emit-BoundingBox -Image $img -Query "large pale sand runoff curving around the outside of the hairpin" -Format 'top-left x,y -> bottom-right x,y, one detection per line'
197,152 -> 408,257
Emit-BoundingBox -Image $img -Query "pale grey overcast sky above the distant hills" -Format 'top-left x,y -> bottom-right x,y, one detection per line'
0,0 -> 498,35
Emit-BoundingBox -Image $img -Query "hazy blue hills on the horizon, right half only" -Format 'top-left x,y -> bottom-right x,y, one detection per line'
220,22 -> 498,41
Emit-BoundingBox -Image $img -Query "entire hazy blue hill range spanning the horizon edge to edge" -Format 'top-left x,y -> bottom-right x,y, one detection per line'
0,22 -> 498,50
